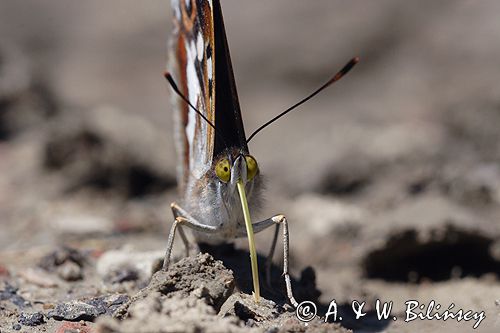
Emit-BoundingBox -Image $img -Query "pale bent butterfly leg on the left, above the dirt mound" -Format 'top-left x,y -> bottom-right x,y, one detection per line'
163,203 -> 219,270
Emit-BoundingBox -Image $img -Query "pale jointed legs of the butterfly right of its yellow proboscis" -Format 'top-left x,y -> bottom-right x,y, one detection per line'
253,214 -> 299,308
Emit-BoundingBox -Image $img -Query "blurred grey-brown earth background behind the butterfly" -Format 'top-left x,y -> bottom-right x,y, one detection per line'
0,0 -> 500,330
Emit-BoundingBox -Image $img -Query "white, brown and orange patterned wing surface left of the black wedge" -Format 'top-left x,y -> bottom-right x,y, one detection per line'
169,0 -> 215,191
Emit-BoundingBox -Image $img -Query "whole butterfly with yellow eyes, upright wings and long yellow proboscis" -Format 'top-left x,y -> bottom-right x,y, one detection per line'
163,0 -> 358,307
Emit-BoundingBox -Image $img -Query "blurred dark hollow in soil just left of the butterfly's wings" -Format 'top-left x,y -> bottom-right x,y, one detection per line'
43,130 -> 176,198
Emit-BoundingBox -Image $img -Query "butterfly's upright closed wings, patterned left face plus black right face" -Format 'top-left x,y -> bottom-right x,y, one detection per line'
169,0 -> 248,191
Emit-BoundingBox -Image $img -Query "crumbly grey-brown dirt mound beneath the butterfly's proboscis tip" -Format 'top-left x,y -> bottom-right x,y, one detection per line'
101,254 -> 348,333
